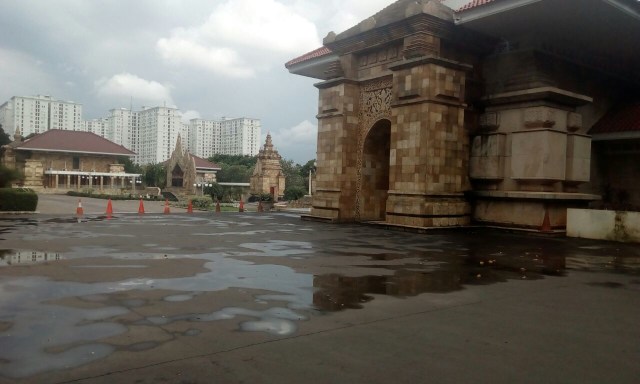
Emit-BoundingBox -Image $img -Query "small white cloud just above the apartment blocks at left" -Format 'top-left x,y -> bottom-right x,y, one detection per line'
95,73 -> 173,105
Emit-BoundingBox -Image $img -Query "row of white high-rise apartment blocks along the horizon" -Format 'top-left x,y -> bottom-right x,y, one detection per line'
0,95 -> 262,164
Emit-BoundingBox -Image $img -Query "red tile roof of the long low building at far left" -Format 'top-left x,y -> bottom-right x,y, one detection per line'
14,129 -> 135,156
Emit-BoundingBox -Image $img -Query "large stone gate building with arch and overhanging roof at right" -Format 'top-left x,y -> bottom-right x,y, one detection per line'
285,0 -> 640,231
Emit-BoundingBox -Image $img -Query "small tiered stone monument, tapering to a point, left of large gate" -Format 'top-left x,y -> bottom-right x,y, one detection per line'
250,133 -> 285,201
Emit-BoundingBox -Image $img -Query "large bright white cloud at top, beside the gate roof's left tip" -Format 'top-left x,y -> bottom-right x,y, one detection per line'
156,0 -> 321,78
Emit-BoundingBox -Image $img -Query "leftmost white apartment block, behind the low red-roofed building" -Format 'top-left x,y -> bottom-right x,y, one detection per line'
0,95 -> 84,136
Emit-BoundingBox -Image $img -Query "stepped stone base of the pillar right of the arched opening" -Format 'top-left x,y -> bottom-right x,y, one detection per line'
385,191 -> 470,228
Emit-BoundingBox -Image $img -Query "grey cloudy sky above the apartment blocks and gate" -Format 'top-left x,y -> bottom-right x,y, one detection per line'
0,0 -> 465,164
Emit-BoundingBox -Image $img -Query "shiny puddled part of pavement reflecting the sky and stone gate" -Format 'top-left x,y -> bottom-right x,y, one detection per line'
0,214 -> 640,377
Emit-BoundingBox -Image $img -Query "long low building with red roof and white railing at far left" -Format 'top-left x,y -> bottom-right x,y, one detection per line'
1,129 -> 140,191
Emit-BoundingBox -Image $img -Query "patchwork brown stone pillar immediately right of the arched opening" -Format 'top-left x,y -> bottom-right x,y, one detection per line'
386,57 -> 470,227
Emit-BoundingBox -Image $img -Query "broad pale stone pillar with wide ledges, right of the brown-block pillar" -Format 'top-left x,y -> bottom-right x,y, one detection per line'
470,92 -> 597,231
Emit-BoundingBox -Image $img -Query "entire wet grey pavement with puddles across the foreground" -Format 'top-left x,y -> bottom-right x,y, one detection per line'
0,208 -> 640,383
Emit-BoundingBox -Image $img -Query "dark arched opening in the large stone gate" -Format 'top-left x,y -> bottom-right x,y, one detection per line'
360,120 -> 391,221
